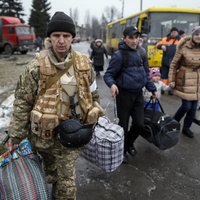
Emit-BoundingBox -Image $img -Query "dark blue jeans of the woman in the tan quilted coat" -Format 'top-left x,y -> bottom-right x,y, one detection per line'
174,99 -> 198,129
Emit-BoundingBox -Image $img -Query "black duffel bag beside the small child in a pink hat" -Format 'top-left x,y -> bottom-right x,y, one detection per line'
141,98 -> 180,150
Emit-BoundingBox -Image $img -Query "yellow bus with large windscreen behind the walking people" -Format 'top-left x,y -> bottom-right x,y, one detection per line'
106,8 -> 200,67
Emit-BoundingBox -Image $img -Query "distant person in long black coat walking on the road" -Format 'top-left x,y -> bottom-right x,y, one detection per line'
90,39 -> 108,76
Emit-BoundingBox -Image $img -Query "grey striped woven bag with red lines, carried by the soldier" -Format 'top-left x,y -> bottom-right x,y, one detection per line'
0,139 -> 51,200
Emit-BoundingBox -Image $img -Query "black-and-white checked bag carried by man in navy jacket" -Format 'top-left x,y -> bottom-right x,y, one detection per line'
81,116 -> 124,172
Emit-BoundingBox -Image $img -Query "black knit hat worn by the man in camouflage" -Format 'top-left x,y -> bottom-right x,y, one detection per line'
47,12 -> 76,38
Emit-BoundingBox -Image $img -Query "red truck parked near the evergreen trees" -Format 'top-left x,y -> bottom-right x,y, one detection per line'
0,16 -> 34,55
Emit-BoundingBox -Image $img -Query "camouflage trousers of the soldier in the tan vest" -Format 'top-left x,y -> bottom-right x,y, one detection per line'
32,138 -> 80,200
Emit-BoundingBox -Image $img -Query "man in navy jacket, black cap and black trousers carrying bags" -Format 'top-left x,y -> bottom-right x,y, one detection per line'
104,26 -> 156,163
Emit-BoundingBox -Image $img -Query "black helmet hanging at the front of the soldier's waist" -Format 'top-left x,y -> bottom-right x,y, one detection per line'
55,119 -> 94,147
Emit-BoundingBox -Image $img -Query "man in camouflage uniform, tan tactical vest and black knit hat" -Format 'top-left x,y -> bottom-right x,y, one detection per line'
7,12 -> 103,200
